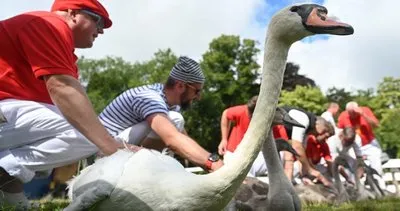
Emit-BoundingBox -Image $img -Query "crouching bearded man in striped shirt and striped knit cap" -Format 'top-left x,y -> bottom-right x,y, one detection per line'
100,57 -> 223,171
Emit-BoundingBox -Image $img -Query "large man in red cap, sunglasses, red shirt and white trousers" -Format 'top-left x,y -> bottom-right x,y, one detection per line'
0,0 -> 137,207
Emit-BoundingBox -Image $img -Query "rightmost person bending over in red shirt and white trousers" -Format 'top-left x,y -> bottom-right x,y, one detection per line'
338,102 -> 382,174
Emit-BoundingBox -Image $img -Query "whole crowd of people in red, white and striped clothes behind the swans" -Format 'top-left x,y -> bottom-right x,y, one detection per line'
0,0 -> 382,208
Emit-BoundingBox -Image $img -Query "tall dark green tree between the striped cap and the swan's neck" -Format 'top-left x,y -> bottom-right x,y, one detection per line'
185,35 -> 259,151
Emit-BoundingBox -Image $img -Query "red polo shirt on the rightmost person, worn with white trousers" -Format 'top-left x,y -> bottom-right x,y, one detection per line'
338,107 -> 378,146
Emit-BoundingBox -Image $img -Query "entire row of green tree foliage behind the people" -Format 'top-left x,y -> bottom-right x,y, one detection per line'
78,35 -> 400,156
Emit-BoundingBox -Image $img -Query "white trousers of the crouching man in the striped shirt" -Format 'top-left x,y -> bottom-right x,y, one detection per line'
117,111 -> 185,145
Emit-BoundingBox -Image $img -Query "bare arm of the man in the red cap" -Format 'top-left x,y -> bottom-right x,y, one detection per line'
44,75 -> 122,155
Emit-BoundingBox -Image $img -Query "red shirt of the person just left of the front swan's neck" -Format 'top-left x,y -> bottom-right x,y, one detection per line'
226,105 -> 250,152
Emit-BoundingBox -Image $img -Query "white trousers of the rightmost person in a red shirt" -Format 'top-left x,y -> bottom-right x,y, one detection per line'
361,139 -> 383,175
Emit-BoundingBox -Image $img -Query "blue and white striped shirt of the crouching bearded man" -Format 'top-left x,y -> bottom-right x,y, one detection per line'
99,83 -> 180,136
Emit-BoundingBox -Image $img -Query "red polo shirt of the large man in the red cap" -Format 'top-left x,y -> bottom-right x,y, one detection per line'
0,12 -> 78,104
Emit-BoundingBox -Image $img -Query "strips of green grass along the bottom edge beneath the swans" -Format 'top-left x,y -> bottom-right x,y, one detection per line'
0,198 -> 400,211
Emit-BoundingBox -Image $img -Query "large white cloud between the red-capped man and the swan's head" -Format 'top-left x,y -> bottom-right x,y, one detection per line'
82,0 -> 263,61
